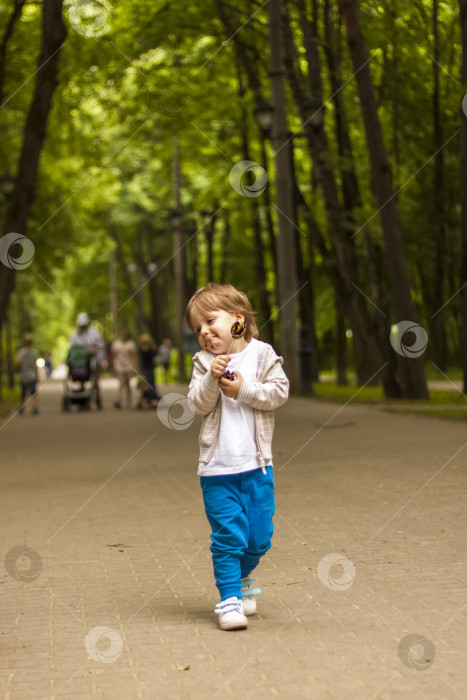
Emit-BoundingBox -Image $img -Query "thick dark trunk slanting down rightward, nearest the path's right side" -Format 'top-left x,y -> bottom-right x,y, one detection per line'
340,0 -> 428,399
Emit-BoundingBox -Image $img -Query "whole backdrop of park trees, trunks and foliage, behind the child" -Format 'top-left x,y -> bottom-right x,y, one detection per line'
0,0 -> 467,398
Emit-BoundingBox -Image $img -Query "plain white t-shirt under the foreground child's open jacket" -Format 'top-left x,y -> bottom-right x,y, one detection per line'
198,338 -> 261,476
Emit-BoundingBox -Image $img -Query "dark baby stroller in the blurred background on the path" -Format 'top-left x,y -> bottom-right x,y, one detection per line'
62,345 -> 102,412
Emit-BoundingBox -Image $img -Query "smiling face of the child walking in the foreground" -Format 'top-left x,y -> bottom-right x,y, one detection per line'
191,309 -> 245,355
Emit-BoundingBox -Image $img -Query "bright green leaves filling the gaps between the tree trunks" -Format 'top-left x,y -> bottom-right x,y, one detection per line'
0,0 -> 463,388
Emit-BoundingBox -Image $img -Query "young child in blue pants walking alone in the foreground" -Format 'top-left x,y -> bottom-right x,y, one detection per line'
186,283 -> 289,630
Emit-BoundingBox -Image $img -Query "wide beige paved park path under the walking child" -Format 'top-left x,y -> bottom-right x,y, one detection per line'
0,384 -> 467,700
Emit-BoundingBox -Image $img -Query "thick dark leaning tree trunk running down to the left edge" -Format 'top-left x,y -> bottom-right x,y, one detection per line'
0,0 -> 66,328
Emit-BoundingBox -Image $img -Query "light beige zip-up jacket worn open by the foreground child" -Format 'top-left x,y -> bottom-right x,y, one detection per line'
188,338 -> 289,470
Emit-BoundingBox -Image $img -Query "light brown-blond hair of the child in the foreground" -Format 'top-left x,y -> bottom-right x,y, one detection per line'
185,282 -> 258,340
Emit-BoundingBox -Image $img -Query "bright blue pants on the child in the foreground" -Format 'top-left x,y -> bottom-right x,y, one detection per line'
201,467 -> 274,600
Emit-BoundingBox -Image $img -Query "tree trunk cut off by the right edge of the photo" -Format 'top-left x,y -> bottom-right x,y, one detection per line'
459,0 -> 467,394
